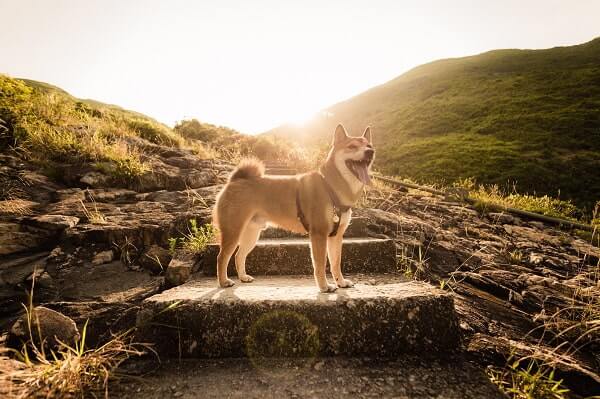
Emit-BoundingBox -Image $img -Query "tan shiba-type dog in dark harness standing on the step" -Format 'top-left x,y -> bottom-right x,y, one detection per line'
213,124 -> 375,292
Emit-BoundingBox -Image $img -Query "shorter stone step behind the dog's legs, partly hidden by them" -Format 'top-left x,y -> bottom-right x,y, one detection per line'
202,238 -> 396,276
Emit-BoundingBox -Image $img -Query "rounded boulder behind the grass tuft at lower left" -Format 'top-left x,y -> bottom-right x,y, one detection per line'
7,306 -> 80,351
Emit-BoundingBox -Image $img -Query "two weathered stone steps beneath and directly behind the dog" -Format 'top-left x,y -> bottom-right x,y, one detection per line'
137,219 -> 460,358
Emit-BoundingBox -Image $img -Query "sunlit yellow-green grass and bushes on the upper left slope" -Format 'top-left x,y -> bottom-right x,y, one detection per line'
0,75 -> 184,182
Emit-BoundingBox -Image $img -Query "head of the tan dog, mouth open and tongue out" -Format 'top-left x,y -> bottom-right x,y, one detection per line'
331,124 -> 375,184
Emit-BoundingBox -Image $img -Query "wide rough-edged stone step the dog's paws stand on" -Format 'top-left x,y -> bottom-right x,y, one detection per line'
137,276 -> 460,358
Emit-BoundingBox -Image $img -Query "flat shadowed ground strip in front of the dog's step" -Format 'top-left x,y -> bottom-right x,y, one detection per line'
110,358 -> 504,399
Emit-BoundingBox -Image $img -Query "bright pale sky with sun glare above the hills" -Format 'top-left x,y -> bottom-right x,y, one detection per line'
0,0 -> 600,134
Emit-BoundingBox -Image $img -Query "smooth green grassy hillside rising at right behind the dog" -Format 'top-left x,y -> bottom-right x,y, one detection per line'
266,38 -> 600,209
